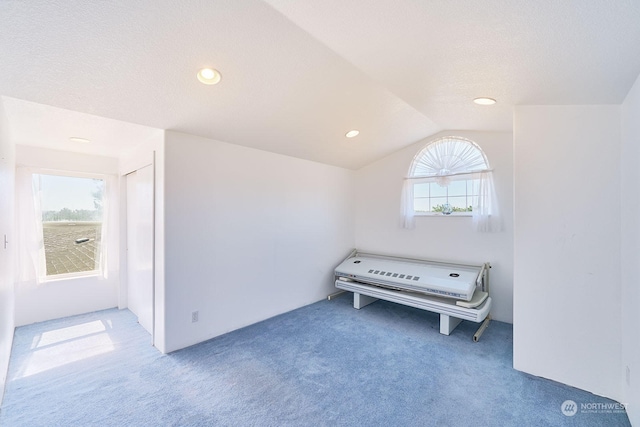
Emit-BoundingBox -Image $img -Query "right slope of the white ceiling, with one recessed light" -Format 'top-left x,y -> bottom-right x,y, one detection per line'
266,0 -> 640,130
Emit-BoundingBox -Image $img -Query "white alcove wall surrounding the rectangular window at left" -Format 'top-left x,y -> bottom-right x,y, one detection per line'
15,145 -> 119,326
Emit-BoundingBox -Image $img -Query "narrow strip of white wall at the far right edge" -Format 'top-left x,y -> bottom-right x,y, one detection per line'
620,72 -> 640,426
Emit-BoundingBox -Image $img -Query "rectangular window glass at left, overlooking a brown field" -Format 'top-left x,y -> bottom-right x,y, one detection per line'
39,175 -> 104,276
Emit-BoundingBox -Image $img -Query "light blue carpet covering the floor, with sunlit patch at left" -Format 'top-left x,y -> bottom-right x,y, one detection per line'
0,296 -> 629,427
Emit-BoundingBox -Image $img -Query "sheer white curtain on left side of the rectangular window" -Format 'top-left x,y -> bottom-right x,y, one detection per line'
16,167 -> 47,284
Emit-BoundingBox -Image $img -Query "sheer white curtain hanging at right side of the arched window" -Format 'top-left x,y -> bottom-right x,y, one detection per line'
472,171 -> 502,232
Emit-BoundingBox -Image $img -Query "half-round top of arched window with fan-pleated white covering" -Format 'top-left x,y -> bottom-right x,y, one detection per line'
409,136 -> 489,178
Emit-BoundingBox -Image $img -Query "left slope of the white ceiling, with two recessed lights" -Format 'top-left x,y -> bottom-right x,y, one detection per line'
0,0 -> 440,169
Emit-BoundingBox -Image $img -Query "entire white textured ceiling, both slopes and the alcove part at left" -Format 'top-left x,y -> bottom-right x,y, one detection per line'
0,0 -> 640,169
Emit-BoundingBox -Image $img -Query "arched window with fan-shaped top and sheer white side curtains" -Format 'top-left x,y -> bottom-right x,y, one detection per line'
402,136 -> 500,231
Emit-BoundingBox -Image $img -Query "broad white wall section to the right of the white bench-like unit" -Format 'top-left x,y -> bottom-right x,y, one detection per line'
514,106 -> 621,399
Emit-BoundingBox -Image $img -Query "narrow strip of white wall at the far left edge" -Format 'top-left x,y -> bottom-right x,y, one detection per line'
0,98 -> 15,403
